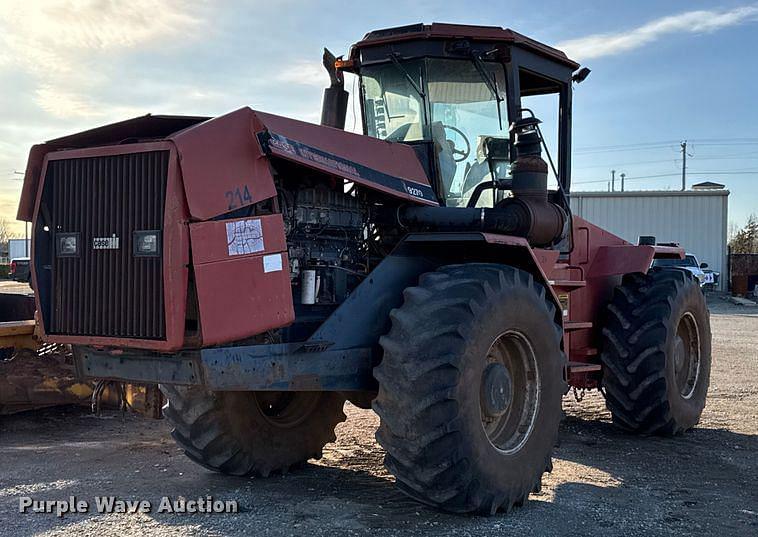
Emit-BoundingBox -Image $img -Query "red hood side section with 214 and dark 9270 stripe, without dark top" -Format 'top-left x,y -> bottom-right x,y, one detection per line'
169,108 -> 437,220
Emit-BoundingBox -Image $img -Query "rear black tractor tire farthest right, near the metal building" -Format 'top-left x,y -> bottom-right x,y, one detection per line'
601,269 -> 711,436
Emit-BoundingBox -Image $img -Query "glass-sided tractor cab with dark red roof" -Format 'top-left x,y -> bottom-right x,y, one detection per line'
333,24 -> 589,211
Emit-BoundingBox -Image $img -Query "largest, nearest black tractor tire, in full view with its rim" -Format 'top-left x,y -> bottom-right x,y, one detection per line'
374,263 -> 566,514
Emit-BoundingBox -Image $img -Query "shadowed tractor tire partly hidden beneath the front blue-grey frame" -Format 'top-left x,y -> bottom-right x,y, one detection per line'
161,385 -> 345,477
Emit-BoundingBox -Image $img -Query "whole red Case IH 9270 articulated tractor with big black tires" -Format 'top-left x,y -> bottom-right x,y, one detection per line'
19,24 -> 711,513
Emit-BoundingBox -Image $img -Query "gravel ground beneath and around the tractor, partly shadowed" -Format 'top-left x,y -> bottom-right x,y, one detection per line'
0,300 -> 758,537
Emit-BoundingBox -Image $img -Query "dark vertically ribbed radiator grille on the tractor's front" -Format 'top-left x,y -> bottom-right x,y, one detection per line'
45,151 -> 169,339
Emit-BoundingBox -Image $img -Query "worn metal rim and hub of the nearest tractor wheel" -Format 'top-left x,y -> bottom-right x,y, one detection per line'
479,330 -> 540,454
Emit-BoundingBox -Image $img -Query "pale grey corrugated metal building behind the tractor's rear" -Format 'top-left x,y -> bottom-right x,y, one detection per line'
571,183 -> 729,290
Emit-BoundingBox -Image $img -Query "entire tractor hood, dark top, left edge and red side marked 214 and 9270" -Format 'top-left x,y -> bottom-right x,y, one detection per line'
18,107 -> 438,221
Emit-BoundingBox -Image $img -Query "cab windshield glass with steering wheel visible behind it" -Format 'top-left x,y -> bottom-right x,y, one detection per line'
361,59 -> 508,206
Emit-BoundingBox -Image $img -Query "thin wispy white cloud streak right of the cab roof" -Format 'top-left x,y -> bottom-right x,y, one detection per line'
557,5 -> 758,60
